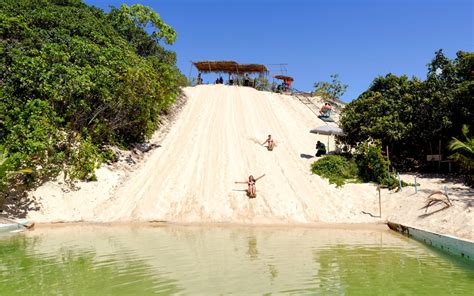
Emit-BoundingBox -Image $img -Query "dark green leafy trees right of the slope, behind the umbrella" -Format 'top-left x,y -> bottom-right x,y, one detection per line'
341,50 -> 474,173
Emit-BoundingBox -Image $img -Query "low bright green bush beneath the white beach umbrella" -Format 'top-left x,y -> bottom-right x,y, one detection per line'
311,155 -> 357,187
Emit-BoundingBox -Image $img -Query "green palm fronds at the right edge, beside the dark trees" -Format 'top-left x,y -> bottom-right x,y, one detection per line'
448,125 -> 474,182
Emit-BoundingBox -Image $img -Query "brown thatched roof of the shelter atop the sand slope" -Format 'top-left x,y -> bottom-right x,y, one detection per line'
193,61 -> 267,73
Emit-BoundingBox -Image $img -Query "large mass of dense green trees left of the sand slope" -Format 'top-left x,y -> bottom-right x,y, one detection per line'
0,0 -> 185,203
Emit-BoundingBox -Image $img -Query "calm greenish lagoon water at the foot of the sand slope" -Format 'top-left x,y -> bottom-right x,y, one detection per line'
0,225 -> 474,295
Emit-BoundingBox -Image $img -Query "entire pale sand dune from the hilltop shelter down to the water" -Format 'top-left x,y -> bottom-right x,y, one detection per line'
30,85 -> 473,236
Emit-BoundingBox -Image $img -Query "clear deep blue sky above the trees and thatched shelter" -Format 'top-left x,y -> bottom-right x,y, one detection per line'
85,0 -> 474,102
